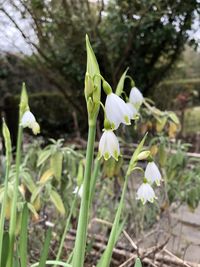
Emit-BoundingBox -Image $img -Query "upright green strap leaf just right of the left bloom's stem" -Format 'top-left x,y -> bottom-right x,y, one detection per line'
19,203 -> 28,267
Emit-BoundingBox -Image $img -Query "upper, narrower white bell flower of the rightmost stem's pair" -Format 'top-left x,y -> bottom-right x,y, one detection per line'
144,161 -> 162,185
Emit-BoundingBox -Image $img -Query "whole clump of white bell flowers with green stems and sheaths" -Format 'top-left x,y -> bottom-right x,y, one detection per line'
0,36 -> 165,267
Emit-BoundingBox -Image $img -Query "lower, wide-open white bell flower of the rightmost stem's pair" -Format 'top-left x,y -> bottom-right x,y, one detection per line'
136,183 -> 157,204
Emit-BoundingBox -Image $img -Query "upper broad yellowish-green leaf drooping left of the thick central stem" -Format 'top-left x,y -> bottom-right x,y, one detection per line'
50,151 -> 63,181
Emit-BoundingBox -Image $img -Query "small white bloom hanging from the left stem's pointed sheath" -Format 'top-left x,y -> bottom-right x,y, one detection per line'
21,110 -> 40,134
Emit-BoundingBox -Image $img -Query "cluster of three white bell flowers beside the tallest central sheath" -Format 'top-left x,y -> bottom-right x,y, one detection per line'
99,87 -> 143,160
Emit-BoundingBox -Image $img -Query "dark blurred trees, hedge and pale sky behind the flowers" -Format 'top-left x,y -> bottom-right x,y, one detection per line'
0,0 -> 200,141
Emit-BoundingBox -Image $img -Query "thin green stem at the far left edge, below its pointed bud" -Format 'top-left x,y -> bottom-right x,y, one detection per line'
0,159 -> 10,264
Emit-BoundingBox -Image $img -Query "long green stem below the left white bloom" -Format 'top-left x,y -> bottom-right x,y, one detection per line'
7,125 -> 22,267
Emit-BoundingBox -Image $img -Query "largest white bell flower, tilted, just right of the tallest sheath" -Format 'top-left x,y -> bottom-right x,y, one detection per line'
105,93 -> 132,129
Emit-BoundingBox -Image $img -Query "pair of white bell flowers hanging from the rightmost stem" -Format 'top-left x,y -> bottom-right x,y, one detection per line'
136,161 -> 162,204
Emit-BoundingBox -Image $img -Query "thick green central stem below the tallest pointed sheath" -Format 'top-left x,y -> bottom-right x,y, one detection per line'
72,120 -> 96,267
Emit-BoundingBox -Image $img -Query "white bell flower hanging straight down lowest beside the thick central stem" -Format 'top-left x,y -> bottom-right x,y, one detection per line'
99,130 -> 120,160
